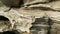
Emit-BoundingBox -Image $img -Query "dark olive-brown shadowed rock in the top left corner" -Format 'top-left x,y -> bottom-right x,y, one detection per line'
0,0 -> 23,7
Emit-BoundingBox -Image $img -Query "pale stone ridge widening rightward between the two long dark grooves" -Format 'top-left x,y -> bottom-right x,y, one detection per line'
25,0 -> 60,11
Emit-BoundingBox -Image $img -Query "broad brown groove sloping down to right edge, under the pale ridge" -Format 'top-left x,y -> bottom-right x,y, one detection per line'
27,6 -> 60,12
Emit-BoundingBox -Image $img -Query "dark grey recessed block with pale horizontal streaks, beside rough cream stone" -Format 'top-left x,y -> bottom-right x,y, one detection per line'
30,17 -> 48,34
